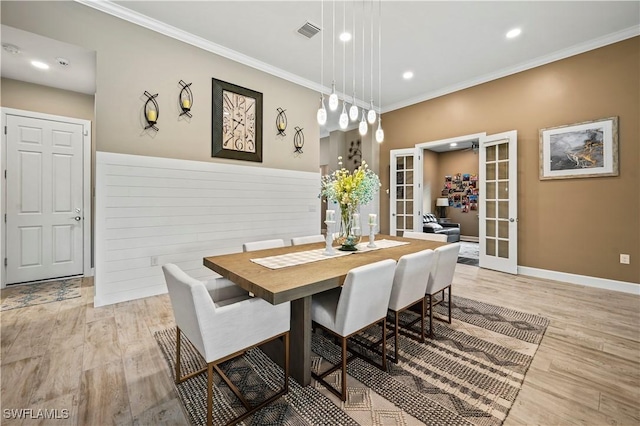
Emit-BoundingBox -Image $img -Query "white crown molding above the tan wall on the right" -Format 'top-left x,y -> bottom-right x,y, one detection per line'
382,26 -> 640,113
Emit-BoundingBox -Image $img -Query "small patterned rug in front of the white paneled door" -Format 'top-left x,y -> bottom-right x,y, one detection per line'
0,278 -> 82,311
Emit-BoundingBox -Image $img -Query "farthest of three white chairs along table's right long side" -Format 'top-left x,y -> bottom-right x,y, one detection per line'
425,243 -> 460,337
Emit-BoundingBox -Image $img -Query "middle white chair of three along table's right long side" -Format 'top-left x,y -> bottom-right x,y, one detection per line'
387,250 -> 435,363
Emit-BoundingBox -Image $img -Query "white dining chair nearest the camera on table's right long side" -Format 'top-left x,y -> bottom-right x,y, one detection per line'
311,259 -> 396,401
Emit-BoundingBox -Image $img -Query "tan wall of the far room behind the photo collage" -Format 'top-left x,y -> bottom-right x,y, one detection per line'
438,151 -> 478,237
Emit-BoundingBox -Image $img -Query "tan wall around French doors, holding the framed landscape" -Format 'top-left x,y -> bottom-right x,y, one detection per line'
380,37 -> 640,283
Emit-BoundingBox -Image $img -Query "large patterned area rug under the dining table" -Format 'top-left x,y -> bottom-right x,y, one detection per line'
155,296 -> 548,426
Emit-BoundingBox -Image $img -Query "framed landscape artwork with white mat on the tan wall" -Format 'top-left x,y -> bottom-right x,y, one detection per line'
540,117 -> 618,180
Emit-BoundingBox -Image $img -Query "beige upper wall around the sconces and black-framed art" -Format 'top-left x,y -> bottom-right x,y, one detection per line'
1,1 -> 319,172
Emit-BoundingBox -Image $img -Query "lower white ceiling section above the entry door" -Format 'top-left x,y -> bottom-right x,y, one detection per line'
0,25 -> 96,95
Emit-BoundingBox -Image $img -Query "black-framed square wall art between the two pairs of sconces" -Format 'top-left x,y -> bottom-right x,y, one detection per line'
211,78 -> 262,162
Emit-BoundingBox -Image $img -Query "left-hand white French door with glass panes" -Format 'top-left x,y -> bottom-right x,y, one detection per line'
389,148 -> 422,236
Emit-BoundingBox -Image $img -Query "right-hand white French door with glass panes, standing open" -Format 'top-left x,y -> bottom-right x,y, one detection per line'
479,130 -> 518,274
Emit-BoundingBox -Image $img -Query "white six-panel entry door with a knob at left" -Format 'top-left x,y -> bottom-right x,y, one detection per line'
5,115 -> 84,284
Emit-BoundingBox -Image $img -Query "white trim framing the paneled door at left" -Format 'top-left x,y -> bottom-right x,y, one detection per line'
0,108 -> 92,288
